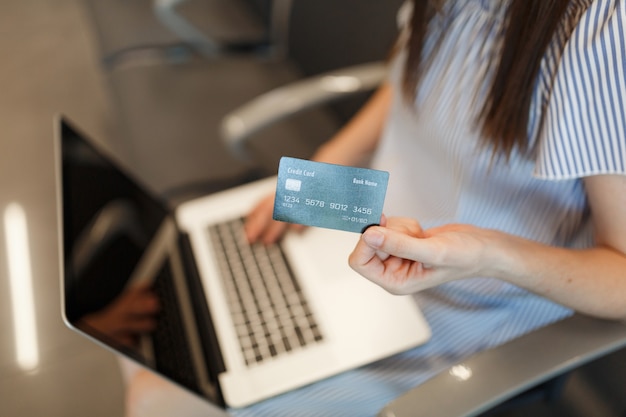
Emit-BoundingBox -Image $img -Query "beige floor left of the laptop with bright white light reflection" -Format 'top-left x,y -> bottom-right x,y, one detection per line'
0,0 -> 123,417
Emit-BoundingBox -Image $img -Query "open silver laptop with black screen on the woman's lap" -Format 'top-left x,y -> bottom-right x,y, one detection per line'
55,116 -> 430,407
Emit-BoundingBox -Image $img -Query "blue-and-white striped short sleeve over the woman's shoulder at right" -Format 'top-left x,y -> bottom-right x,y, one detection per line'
539,0 -> 626,178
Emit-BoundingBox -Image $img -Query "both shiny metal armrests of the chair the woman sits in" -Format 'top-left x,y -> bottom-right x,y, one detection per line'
221,62 -> 626,417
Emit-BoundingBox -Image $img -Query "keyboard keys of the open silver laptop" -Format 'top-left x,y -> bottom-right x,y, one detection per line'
209,219 -> 323,365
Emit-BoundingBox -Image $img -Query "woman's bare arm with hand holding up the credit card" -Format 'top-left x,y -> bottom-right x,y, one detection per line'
350,175 -> 626,320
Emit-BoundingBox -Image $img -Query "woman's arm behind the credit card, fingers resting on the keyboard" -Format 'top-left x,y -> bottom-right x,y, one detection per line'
245,84 -> 391,244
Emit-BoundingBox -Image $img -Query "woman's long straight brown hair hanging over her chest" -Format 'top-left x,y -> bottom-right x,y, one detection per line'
403,0 -> 569,157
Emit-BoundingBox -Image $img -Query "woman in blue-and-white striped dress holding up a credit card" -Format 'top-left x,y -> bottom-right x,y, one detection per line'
241,0 -> 626,416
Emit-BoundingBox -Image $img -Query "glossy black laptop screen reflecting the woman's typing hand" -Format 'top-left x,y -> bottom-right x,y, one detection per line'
60,120 -> 219,402
